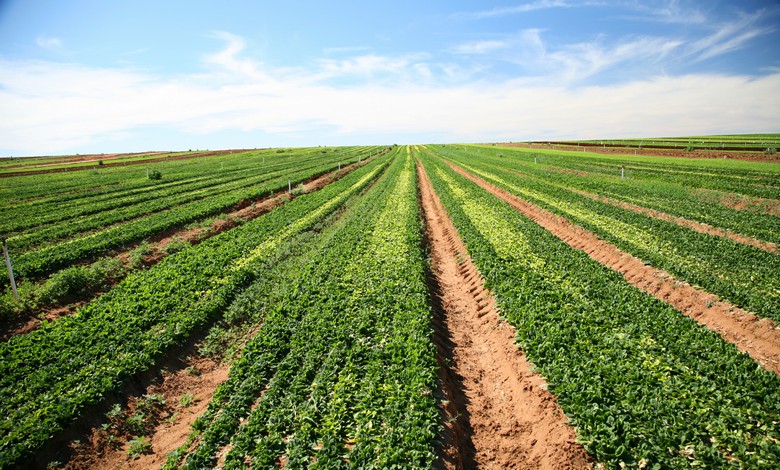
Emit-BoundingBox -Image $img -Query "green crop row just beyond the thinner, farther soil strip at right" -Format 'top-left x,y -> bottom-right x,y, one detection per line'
450,148 -> 780,243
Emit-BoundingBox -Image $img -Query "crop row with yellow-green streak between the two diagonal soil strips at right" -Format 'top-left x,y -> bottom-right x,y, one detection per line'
436,151 -> 780,321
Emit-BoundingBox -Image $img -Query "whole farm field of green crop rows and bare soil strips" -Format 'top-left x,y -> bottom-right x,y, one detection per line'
0,141 -> 780,469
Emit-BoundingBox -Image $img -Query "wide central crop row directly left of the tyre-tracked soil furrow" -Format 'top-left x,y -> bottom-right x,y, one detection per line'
168,149 -> 438,468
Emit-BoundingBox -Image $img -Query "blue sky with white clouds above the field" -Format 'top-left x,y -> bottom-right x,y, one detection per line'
0,0 -> 780,157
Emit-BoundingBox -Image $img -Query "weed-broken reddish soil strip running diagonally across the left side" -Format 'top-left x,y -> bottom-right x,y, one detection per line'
0,159 -> 370,341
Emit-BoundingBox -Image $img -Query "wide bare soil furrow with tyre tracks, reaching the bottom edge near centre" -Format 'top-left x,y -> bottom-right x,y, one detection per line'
418,162 -> 592,469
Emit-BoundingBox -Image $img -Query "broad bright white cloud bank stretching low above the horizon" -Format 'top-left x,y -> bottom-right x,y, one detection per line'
0,34 -> 780,155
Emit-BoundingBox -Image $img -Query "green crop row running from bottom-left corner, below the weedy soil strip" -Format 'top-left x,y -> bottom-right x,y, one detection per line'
0,152 -> 388,467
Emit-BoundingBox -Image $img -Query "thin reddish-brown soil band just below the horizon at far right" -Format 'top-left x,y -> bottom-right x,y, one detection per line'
494,142 -> 780,162
